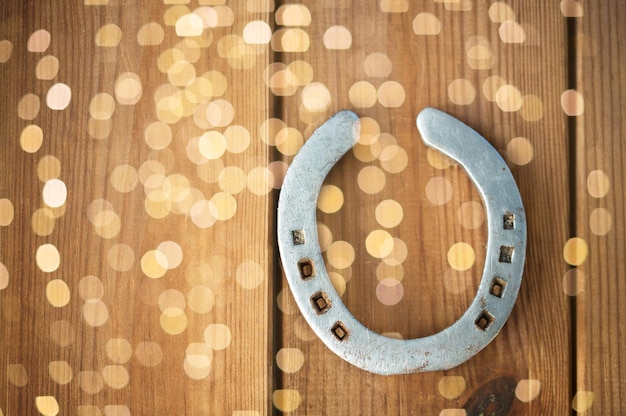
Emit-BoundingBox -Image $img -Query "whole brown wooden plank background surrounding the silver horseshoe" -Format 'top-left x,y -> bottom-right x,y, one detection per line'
0,0 -> 626,416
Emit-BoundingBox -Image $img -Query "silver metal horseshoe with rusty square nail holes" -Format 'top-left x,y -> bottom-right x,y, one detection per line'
277,108 -> 526,374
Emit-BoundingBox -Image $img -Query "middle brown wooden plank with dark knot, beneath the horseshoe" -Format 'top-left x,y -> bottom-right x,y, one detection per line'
272,1 -> 571,415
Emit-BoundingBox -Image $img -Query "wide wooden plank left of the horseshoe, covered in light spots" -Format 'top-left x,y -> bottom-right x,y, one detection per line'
0,0 -> 272,416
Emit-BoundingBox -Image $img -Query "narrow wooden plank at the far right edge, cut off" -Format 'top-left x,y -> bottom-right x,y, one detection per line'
576,1 -> 626,415
